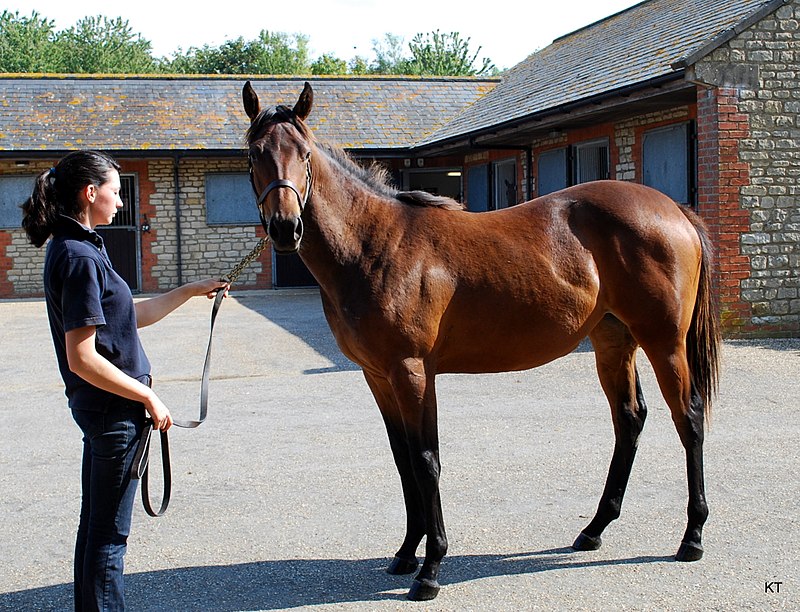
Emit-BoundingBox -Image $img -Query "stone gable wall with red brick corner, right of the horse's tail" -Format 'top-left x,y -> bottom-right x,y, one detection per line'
695,2 -> 800,336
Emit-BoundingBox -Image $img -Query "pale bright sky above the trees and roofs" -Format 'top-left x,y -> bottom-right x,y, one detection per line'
3,0 -> 640,69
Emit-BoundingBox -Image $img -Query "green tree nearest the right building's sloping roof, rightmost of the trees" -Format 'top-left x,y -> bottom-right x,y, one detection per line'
407,30 -> 497,76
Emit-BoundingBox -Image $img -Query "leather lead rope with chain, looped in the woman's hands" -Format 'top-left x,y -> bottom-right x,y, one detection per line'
131,238 -> 268,517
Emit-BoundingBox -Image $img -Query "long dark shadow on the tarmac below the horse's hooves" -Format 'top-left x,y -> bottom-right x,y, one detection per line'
0,548 -> 672,612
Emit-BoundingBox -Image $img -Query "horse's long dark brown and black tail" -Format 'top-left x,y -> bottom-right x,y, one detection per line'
681,206 -> 721,417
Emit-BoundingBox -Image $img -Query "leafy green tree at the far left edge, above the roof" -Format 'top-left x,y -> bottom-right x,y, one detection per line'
0,11 -> 57,72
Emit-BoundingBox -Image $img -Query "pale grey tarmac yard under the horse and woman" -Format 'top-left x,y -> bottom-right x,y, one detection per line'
0,290 -> 800,611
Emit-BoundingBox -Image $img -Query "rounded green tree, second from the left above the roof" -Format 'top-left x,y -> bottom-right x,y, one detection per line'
55,15 -> 156,74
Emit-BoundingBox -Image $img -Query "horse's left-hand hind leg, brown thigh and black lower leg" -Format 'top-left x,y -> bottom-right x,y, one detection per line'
572,315 -> 647,550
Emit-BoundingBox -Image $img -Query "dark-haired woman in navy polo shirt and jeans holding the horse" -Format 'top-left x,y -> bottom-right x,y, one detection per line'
22,151 -> 226,610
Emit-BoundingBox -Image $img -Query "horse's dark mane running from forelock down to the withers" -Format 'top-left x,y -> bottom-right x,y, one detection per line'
245,106 -> 464,210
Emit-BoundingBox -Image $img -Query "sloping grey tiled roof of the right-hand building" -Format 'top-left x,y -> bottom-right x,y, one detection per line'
418,0 -> 789,145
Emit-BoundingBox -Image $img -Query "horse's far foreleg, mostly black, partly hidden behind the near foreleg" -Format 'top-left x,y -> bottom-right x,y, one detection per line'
364,372 -> 425,574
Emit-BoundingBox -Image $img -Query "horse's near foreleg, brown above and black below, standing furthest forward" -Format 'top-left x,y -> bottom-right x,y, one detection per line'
391,359 -> 447,601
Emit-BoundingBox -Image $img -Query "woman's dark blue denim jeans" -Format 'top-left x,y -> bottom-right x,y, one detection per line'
72,400 -> 145,611
